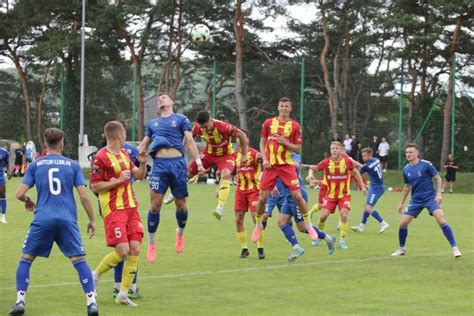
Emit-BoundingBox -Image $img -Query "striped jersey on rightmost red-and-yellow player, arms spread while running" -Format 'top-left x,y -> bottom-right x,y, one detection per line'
314,155 -> 354,199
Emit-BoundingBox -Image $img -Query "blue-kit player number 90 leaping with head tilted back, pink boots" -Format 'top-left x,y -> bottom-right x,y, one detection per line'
138,93 -> 204,263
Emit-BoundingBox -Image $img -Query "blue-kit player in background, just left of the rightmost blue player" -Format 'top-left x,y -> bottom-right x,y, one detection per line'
351,147 -> 389,233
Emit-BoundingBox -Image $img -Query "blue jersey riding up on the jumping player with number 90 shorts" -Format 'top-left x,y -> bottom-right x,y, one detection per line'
145,113 -> 192,156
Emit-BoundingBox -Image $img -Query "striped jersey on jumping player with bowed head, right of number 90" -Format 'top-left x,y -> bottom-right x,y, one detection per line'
193,119 -> 239,156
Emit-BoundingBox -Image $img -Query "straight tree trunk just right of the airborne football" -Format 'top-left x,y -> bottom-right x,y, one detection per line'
234,0 -> 248,131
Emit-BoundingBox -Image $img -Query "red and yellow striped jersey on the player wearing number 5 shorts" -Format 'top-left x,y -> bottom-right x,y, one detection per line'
90,147 -> 138,217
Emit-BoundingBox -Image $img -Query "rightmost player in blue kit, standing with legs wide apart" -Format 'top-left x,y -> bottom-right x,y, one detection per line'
392,144 -> 462,258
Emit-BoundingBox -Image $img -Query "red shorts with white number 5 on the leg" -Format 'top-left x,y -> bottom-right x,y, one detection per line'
104,208 -> 143,247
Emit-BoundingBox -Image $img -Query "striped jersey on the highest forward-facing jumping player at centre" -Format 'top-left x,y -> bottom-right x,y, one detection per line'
261,117 -> 302,166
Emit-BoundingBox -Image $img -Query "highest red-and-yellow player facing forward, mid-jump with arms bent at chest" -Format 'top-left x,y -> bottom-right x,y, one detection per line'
252,97 -> 318,242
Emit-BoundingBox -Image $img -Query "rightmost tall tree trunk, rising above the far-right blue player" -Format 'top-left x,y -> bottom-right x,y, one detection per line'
439,17 -> 462,170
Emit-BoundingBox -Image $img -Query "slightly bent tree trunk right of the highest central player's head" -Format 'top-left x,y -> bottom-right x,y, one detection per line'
319,0 -> 337,133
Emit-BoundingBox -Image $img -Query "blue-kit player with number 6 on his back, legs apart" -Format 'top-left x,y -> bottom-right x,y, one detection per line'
9,128 -> 99,315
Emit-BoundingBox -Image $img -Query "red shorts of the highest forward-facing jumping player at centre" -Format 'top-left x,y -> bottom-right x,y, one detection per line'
260,165 -> 300,191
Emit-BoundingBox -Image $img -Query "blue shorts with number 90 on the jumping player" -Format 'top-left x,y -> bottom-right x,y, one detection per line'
150,157 -> 188,199
